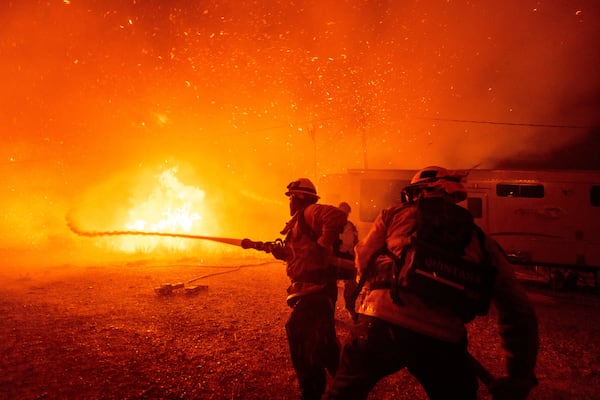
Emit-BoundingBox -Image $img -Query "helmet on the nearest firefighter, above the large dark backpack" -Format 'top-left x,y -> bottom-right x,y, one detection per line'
403,165 -> 467,203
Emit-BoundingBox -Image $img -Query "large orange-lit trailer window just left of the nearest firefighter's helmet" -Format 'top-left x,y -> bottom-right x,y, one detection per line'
359,179 -> 410,222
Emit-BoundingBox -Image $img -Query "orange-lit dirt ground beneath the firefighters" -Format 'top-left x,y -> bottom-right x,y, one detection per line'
0,259 -> 600,400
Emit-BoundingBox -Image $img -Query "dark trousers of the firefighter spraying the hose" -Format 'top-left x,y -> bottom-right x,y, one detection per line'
285,293 -> 340,400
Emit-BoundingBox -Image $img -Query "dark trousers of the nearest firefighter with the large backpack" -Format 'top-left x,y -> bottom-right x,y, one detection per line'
326,315 -> 478,400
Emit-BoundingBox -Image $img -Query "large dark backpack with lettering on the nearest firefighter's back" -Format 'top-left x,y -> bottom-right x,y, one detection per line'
388,197 -> 497,322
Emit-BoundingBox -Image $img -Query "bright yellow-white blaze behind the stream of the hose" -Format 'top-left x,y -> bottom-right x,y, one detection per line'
117,167 -> 205,253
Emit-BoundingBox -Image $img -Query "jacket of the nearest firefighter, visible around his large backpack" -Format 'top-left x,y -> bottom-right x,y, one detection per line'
356,203 -> 539,377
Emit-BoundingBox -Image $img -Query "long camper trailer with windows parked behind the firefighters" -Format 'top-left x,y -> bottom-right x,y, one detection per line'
318,169 -> 600,288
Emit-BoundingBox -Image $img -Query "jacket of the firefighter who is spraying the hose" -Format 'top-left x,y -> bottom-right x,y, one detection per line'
282,204 -> 347,295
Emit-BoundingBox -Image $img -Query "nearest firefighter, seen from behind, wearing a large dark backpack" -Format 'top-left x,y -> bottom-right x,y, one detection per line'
326,166 -> 539,400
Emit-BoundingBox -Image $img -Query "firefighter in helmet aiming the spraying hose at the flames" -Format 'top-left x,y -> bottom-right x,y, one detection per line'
273,178 -> 347,400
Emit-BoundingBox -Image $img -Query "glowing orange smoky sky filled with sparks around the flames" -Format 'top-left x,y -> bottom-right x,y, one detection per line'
0,0 -> 600,263
